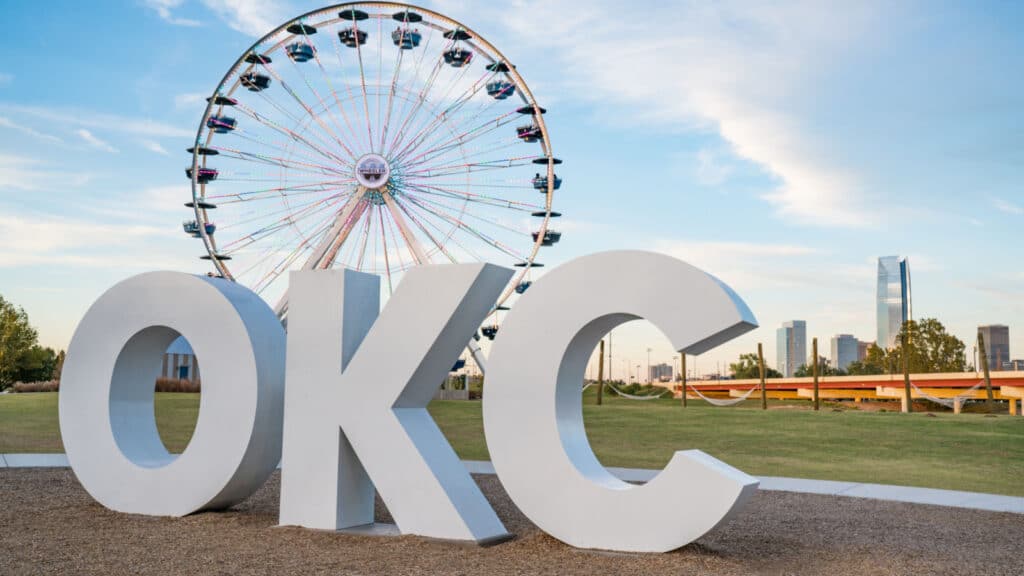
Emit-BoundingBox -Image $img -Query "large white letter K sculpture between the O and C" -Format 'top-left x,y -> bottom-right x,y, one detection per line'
281,264 -> 512,542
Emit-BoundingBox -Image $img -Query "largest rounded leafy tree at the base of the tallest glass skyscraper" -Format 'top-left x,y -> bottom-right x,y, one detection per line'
888,318 -> 967,374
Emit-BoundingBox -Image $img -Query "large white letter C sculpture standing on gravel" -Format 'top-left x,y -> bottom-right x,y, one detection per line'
483,251 -> 758,551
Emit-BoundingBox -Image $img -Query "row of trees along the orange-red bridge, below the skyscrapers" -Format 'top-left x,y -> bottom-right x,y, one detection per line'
729,318 -> 974,379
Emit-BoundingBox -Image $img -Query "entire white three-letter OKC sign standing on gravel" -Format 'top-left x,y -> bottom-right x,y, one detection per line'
59,251 -> 758,551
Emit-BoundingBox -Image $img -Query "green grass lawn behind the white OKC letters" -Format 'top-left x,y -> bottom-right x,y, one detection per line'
0,392 -> 1024,496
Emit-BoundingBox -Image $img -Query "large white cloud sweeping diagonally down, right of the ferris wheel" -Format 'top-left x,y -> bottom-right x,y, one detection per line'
487,0 -> 877,227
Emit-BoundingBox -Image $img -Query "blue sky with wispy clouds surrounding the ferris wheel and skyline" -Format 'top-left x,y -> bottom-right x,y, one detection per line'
0,0 -> 1024,372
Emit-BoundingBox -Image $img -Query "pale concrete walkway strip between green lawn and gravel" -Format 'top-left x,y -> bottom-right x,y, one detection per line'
8,454 -> 1024,515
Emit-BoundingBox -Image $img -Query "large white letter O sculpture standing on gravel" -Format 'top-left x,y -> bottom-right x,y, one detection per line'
58,272 -> 285,516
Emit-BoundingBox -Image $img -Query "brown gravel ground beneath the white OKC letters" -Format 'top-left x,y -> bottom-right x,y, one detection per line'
0,469 -> 1024,576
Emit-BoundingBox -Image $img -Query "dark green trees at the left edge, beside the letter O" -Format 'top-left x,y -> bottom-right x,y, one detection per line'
0,296 -> 65,390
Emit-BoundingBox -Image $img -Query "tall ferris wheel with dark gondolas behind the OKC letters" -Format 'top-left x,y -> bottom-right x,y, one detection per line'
183,2 -> 561,360
